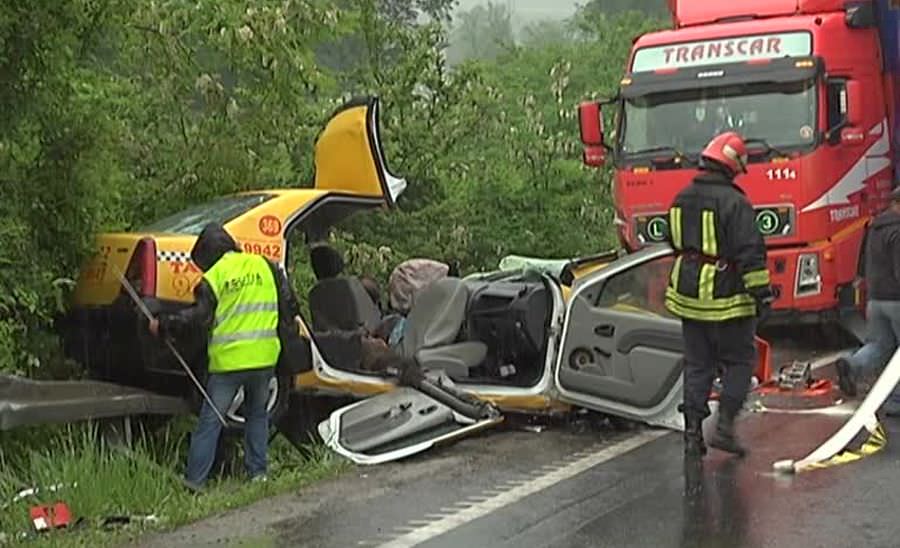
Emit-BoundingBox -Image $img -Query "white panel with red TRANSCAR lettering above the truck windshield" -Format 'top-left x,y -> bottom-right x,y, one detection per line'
631,32 -> 812,72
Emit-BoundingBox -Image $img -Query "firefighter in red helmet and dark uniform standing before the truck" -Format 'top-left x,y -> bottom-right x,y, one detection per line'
666,132 -> 773,456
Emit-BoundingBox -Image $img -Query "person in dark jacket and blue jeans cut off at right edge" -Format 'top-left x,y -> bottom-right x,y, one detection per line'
837,188 -> 900,417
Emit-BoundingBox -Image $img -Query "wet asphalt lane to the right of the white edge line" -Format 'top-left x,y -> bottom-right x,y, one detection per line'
394,414 -> 900,548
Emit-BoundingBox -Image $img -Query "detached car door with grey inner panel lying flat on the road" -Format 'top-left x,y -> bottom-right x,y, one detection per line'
318,380 -> 503,464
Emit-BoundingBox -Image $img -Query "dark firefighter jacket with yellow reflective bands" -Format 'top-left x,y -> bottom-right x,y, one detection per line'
666,171 -> 771,322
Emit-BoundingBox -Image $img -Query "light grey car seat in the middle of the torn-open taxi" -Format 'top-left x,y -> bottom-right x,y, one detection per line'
400,278 -> 488,379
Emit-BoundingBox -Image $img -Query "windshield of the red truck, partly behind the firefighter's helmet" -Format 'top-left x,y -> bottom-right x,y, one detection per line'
619,80 -> 817,161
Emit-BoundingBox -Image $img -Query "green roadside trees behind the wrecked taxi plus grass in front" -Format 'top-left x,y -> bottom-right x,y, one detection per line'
0,0 -> 666,545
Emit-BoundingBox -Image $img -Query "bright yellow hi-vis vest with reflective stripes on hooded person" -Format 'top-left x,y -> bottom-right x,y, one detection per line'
203,252 -> 281,373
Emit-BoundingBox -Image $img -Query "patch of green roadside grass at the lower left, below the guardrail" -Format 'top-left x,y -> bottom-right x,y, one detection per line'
0,421 -> 349,547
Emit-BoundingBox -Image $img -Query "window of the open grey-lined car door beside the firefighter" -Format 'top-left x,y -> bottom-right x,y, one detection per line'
596,255 -> 674,317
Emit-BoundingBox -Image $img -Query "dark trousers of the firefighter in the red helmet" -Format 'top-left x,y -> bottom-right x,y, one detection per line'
681,318 -> 757,418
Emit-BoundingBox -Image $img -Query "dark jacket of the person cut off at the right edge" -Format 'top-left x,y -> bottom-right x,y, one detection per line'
865,209 -> 900,301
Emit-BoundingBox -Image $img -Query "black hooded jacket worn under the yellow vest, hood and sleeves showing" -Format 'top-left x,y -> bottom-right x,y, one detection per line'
159,224 -> 310,373
